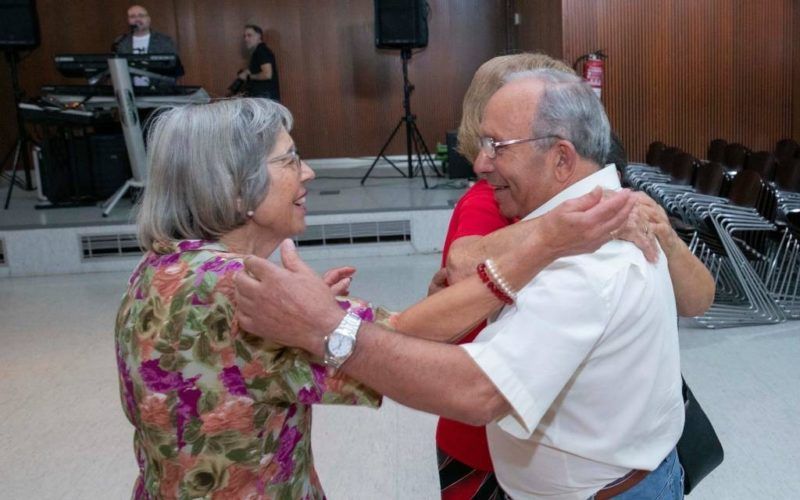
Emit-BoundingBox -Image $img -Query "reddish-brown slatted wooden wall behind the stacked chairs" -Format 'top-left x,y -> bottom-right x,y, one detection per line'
563,0 -> 798,160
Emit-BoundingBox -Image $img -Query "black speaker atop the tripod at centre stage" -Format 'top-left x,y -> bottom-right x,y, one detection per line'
375,0 -> 428,49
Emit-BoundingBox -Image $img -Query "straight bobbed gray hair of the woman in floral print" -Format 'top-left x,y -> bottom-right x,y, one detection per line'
137,98 -> 292,250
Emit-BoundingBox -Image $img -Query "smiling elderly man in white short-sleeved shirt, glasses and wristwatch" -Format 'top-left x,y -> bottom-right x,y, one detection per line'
237,70 -> 684,500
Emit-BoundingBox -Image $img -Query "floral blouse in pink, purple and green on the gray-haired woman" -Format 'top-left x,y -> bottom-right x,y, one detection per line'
115,240 -> 381,500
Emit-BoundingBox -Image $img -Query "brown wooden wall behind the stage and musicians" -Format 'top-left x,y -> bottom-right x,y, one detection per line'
0,0 -> 505,164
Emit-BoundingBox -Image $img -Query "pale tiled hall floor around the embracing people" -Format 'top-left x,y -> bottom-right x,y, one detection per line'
0,255 -> 800,500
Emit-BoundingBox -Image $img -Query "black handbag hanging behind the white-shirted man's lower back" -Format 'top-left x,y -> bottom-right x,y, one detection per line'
677,380 -> 724,495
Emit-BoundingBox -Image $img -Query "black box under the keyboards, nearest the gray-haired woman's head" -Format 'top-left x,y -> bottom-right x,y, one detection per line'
89,134 -> 131,200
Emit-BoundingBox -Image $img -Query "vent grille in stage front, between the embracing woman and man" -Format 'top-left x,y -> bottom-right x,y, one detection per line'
295,220 -> 411,247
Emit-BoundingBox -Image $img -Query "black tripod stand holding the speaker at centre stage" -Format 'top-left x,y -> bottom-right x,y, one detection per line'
361,48 -> 442,189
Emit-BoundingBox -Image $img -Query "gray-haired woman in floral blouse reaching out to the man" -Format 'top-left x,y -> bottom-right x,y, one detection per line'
115,99 -> 633,499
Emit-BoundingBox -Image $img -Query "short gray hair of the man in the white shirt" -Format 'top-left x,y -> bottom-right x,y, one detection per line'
504,69 -> 611,167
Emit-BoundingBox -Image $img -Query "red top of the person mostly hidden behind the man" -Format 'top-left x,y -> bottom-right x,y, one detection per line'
436,180 -> 511,471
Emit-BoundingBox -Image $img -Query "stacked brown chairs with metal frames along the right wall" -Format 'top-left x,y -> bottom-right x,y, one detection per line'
624,139 -> 800,328
